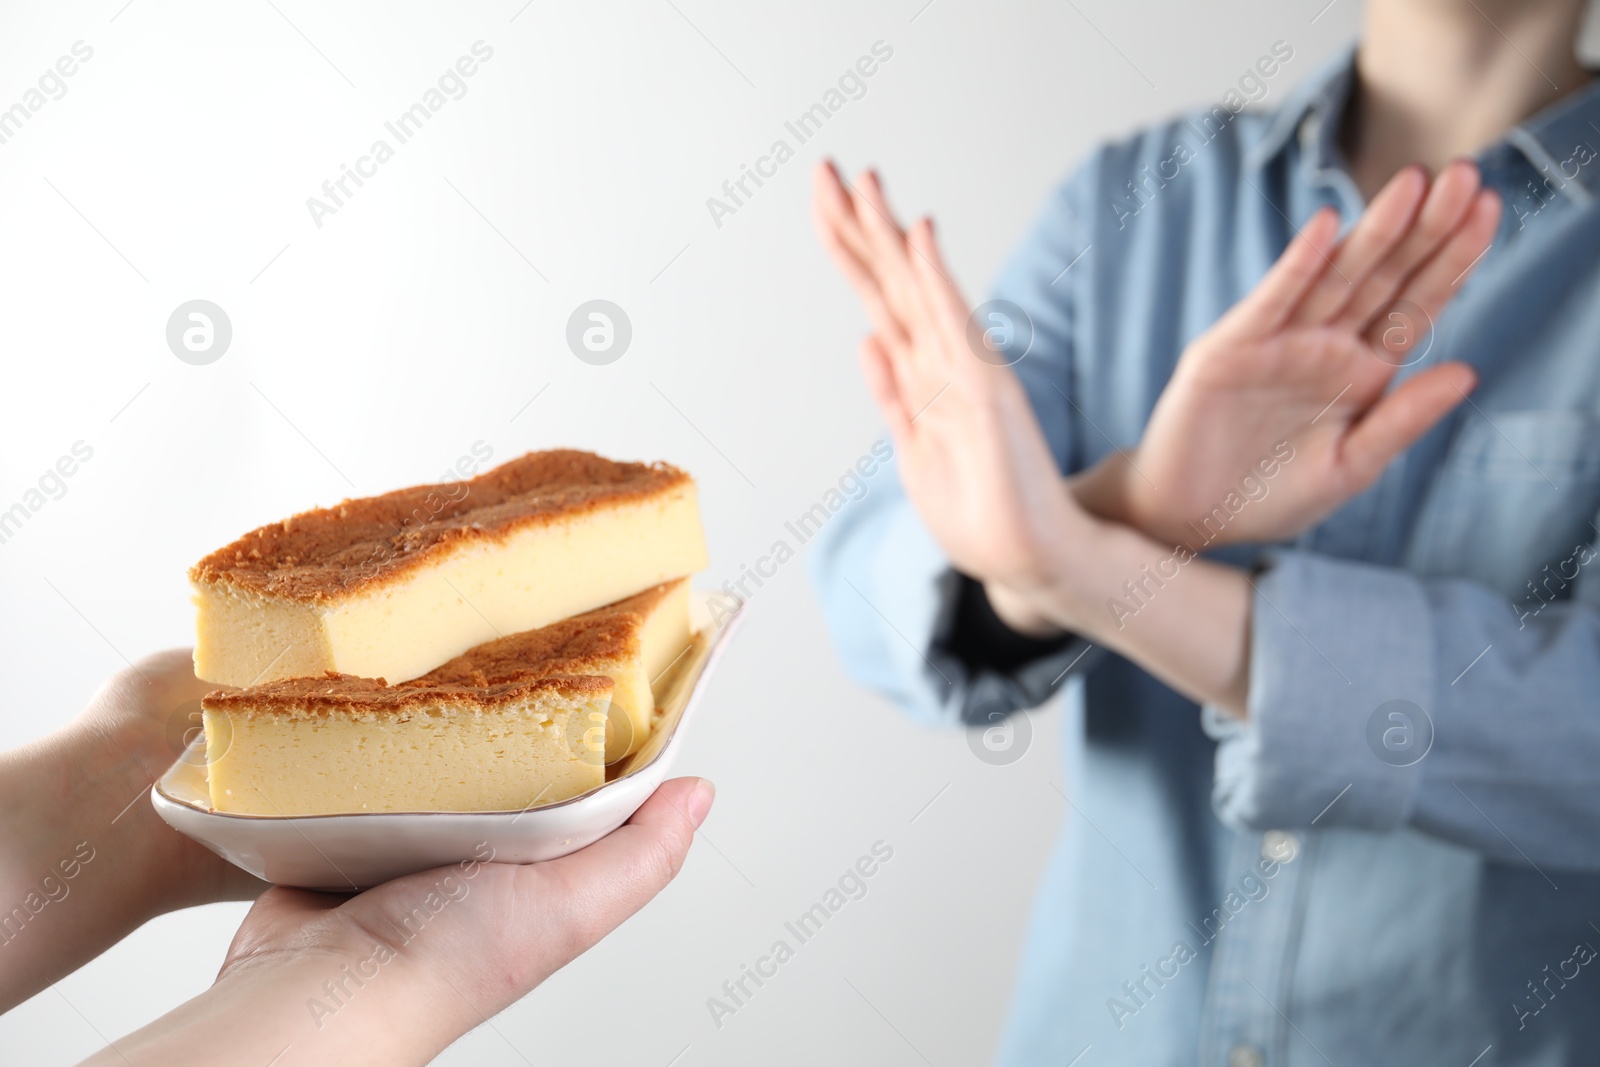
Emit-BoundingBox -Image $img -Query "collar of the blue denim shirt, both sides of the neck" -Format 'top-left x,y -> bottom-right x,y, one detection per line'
1245,45 -> 1600,203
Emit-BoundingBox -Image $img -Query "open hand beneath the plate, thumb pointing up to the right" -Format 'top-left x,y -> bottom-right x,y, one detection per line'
88,777 -> 714,1067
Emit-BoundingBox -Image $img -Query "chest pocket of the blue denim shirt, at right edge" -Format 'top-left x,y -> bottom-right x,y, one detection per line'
1408,411 -> 1600,601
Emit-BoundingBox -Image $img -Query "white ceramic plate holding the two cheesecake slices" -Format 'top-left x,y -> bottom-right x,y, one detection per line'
150,598 -> 742,893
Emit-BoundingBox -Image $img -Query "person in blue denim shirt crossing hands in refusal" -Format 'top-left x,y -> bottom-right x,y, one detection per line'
811,0 -> 1600,1067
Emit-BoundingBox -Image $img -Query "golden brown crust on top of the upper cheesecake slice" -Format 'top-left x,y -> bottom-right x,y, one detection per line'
189,450 -> 693,601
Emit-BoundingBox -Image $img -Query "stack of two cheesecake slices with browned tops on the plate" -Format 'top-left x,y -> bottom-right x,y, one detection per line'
189,451 -> 706,816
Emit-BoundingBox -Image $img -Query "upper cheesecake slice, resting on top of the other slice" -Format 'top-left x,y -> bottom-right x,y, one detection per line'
189,451 -> 706,686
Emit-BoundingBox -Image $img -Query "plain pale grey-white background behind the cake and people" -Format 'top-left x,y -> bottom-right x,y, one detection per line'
0,0 -> 1580,1067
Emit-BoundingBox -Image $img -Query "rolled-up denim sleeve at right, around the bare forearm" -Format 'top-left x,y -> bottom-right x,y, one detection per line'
1208,552 -> 1600,869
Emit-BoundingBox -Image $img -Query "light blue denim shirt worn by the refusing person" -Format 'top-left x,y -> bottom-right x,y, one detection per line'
811,45 -> 1600,1067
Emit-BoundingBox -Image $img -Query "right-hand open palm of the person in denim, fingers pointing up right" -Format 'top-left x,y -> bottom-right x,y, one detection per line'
1074,162 -> 1499,549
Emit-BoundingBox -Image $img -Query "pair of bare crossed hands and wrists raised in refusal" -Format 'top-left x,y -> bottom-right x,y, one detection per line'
813,163 -> 1499,717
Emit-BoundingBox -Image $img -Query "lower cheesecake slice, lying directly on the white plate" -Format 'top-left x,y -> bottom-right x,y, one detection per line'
202,579 -> 691,816
